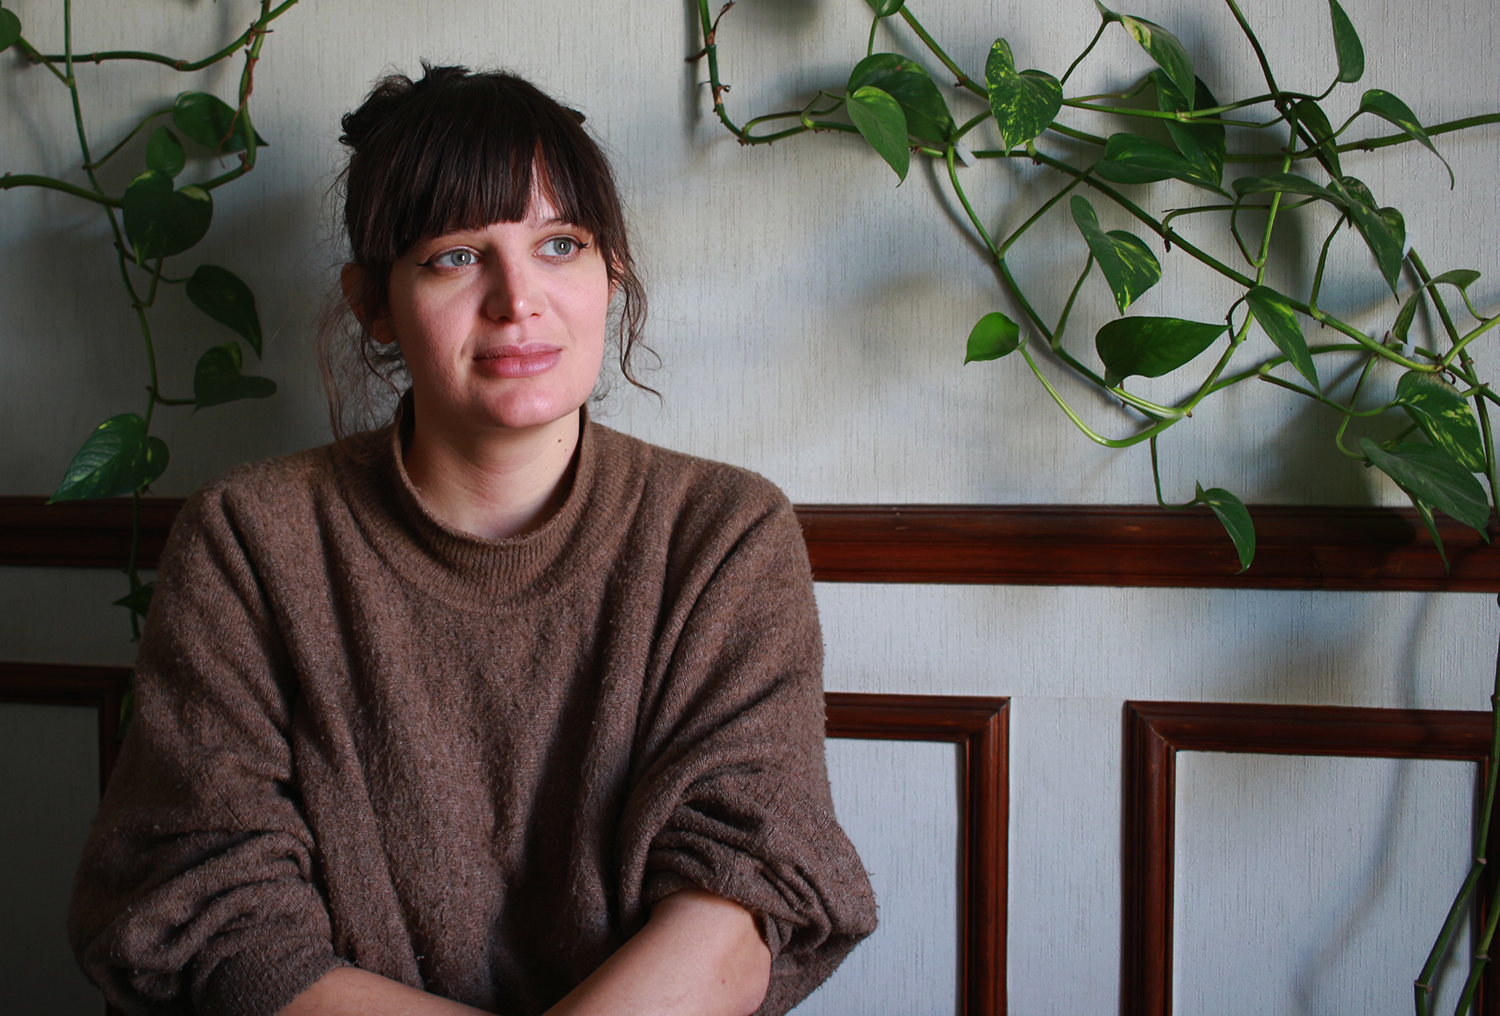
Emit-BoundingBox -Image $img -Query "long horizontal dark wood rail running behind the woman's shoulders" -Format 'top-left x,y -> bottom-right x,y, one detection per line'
0,497 -> 1500,593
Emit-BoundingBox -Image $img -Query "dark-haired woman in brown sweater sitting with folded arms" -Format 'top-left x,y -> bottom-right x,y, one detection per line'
71,68 -> 875,1016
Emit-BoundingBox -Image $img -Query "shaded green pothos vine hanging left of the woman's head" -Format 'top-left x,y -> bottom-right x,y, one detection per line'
0,0 -> 297,651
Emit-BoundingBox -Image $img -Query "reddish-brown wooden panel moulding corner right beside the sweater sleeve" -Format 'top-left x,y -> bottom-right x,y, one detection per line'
827,692 -> 1010,1016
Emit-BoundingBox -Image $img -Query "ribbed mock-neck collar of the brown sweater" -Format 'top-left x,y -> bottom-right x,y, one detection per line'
344,408 -> 633,611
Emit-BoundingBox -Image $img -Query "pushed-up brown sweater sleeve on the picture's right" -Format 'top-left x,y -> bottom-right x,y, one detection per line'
623,492 -> 876,1016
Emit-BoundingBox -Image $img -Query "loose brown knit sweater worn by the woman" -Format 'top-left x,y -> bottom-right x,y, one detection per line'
69,423 -> 875,1016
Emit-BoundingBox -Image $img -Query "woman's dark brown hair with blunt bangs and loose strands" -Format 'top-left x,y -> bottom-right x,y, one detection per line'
318,63 -> 651,438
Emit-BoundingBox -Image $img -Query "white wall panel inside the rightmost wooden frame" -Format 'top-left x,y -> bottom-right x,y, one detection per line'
1173,752 -> 1475,1016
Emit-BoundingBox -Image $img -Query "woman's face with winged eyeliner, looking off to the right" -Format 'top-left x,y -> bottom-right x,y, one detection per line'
372,194 -> 611,441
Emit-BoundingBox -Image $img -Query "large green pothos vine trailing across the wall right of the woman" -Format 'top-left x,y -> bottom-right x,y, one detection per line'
689,0 -> 1500,1016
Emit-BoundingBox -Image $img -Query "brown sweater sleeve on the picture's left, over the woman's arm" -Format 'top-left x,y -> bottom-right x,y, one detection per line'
69,488 -> 342,1016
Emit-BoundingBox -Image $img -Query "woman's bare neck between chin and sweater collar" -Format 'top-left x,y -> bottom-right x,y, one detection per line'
402,407 -> 581,540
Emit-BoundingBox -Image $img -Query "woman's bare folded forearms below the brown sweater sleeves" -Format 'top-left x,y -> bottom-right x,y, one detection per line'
279,888 -> 771,1016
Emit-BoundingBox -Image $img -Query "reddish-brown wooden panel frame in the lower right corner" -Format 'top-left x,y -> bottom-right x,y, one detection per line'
1121,702 -> 1500,1016
